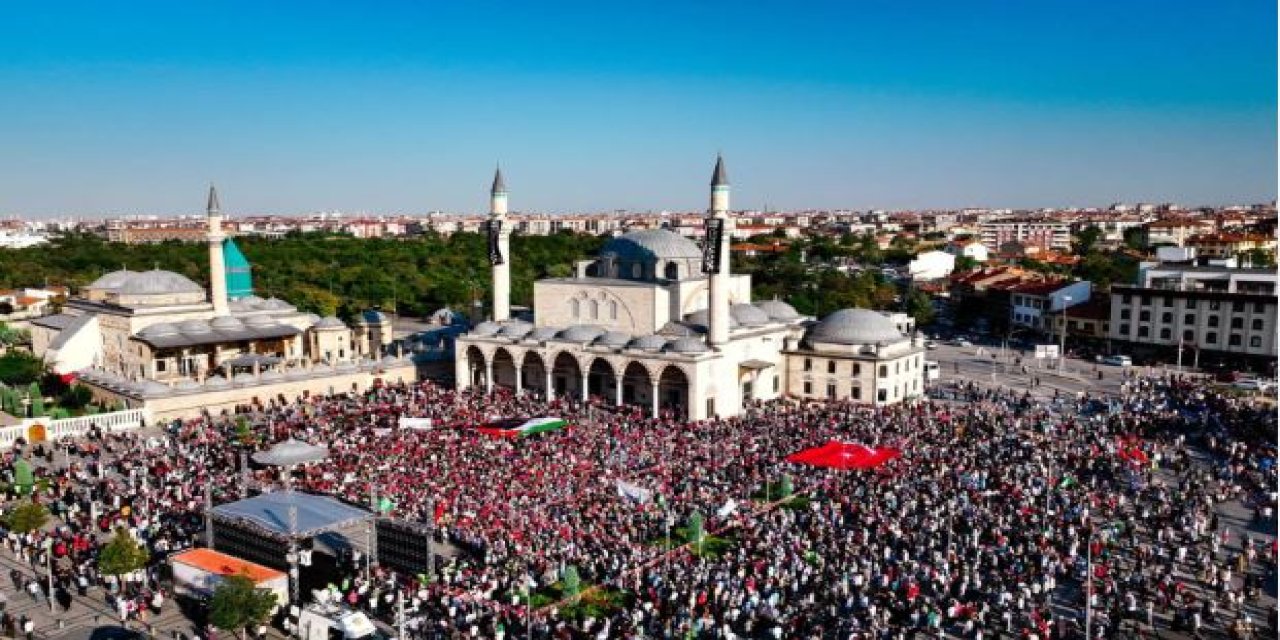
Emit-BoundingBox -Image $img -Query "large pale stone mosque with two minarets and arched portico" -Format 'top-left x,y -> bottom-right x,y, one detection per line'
454,159 -> 924,420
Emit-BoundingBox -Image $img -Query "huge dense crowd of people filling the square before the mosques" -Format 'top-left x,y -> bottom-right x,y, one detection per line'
5,376 -> 1276,640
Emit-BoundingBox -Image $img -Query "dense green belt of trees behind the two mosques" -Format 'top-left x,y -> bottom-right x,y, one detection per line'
0,233 -> 604,317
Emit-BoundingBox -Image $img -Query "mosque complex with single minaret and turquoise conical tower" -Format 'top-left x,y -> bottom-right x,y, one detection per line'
31,187 -> 416,419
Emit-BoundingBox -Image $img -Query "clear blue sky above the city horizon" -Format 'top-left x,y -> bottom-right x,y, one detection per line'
0,0 -> 1276,215
